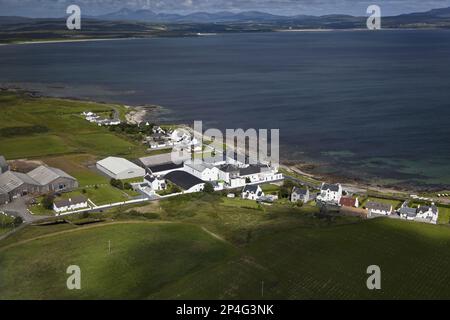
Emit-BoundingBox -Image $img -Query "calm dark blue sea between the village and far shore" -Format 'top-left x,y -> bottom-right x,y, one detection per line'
0,30 -> 450,186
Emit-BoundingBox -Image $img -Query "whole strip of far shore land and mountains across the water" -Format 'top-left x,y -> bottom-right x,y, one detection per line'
0,7 -> 450,43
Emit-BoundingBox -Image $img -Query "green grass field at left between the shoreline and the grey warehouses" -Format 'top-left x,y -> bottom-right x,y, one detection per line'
0,92 -> 145,159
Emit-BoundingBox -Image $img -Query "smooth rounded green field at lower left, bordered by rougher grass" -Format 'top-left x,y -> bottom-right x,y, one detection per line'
0,223 -> 234,299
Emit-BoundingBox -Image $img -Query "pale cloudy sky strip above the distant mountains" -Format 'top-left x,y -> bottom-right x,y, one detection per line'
0,0 -> 450,17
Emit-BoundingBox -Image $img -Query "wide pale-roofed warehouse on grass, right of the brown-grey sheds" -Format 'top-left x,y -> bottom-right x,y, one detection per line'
96,157 -> 145,180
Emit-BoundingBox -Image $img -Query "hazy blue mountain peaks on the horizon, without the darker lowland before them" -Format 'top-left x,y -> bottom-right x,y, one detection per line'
91,7 -> 450,27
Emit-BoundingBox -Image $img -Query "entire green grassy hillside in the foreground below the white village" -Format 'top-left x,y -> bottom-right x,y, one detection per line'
0,194 -> 450,299
